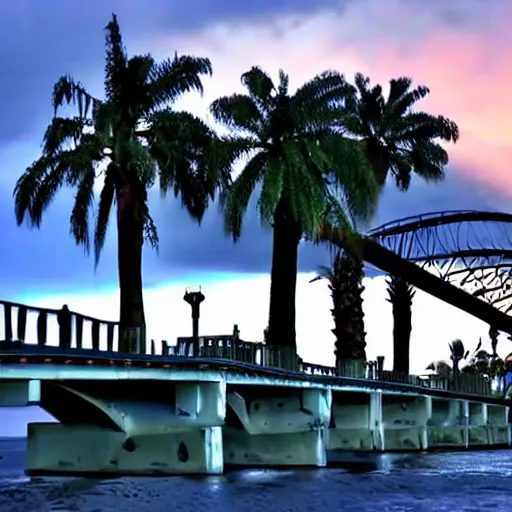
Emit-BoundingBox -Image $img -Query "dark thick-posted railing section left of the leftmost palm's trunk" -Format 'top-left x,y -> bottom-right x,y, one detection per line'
0,301 -> 119,352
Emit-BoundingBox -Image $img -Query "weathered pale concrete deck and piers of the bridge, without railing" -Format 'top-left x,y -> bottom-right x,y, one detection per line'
0,363 -> 512,474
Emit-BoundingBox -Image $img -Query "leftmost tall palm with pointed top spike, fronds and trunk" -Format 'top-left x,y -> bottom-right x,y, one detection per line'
14,15 -> 228,351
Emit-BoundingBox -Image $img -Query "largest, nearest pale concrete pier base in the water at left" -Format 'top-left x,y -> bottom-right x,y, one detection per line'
26,423 -> 224,475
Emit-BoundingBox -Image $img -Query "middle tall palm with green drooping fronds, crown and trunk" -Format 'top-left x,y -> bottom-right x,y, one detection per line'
211,67 -> 377,348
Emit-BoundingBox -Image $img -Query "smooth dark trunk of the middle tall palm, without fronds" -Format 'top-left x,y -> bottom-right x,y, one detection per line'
268,202 -> 301,351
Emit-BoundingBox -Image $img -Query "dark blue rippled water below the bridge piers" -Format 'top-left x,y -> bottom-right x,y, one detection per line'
0,440 -> 512,512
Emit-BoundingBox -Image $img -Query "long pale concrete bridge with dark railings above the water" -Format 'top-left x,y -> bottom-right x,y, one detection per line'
0,296 -> 512,475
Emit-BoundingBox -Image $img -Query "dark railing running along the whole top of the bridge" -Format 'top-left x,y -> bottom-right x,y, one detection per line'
0,301 -> 505,396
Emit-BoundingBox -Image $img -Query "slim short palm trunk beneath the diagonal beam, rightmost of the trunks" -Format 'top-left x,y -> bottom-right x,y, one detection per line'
387,275 -> 416,373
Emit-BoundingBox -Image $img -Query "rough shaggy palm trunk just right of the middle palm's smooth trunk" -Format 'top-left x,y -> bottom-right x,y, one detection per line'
310,249 -> 366,366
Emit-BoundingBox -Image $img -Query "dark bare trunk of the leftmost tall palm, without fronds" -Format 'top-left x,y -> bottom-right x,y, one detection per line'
117,180 -> 146,353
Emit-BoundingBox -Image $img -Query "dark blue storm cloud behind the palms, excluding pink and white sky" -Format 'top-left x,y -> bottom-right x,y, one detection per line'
0,0 -> 510,298
